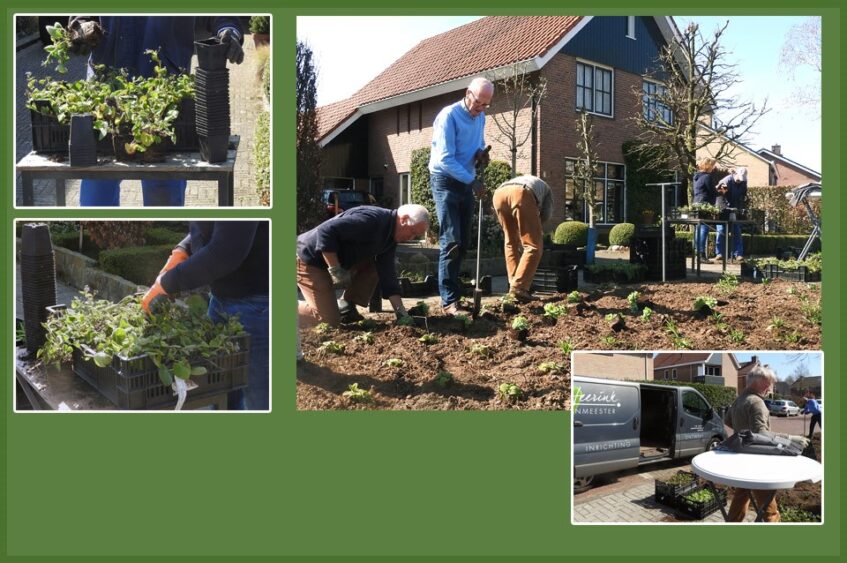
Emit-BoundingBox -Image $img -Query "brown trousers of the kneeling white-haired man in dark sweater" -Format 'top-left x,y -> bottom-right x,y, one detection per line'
297,257 -> 379,328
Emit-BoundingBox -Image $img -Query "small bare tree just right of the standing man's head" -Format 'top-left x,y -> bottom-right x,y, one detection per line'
491,62 -> 547,176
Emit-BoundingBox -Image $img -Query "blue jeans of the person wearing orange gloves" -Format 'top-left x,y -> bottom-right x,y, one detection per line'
209,295 -> 270,411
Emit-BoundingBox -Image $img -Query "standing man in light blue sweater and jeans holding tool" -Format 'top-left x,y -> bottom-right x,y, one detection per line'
429,78 -> 494,315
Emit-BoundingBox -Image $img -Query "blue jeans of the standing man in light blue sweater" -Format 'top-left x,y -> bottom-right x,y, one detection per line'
429,174 -> 474,306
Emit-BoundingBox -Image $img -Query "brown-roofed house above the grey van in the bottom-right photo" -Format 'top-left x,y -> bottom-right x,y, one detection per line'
653,352 -> 740,390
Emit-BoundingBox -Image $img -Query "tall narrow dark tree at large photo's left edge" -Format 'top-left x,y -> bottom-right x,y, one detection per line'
296,41 -> 321,233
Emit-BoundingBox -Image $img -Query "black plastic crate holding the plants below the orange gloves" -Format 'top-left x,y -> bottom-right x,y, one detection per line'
72,334 -> 250,410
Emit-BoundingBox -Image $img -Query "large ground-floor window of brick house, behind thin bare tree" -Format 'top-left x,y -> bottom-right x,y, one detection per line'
565,158 -> 626,223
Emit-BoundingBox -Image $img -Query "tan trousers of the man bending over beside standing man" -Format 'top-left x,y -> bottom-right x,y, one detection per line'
493,184 -> 544,291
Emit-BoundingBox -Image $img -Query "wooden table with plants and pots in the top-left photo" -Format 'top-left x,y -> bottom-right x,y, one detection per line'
15,135 -> 240,207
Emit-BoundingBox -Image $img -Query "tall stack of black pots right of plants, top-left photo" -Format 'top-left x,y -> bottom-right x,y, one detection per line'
194,38 -> 230,162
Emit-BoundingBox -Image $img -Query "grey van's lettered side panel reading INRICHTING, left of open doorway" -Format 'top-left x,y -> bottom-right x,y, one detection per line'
572,378 -> 641,477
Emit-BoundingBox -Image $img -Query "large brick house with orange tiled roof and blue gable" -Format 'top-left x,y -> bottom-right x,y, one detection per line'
318,16 -> 678,229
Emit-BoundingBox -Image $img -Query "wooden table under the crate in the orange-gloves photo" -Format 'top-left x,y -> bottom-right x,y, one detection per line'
15,347 -> 232,412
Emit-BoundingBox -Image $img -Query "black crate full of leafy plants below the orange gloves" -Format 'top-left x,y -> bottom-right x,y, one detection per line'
38,293 -> 249,410
